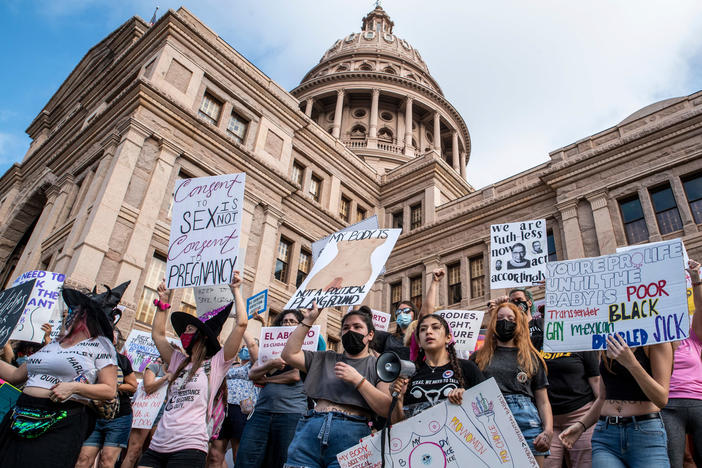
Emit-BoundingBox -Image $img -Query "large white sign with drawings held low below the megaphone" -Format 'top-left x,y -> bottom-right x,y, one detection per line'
336,378 -> 538,468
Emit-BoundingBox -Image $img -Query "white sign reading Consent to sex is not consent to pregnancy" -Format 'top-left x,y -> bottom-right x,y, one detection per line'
166,173 -> 246,289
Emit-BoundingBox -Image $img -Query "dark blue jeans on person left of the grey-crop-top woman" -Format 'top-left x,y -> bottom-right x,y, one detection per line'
234,409 -> 302,468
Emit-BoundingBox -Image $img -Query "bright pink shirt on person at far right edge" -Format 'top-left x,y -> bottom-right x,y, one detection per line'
668,328 -> 702,400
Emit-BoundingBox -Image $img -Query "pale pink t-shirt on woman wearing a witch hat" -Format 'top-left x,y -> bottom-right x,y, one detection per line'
149,350 -> 234,453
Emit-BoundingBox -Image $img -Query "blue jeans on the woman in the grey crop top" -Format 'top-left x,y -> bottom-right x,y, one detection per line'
286,410 -> 370,468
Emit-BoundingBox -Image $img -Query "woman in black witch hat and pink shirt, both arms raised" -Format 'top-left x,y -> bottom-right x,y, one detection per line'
139,271 -> 248,468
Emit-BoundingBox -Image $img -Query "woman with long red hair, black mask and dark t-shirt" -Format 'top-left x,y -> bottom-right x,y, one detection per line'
470,302 -> 553,466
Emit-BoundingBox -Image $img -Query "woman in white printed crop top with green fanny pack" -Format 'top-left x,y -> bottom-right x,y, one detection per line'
0,289 -> 117,468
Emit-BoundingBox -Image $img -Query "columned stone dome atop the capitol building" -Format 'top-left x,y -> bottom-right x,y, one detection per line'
291,6 -> 470,179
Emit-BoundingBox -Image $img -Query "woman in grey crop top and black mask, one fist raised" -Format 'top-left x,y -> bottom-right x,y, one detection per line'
282,303 -> 392,467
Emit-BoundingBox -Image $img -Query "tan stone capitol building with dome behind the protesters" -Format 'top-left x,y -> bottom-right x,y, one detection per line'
0,7 -> 702,347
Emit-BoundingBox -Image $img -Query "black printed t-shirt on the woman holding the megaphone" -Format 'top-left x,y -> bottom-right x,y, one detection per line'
403,359 -> 485,417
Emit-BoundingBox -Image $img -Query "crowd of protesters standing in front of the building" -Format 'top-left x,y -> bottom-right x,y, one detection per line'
0,261 -> 702,468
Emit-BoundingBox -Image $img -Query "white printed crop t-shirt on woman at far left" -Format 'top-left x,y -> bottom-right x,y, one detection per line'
25,336 -> 117,399
